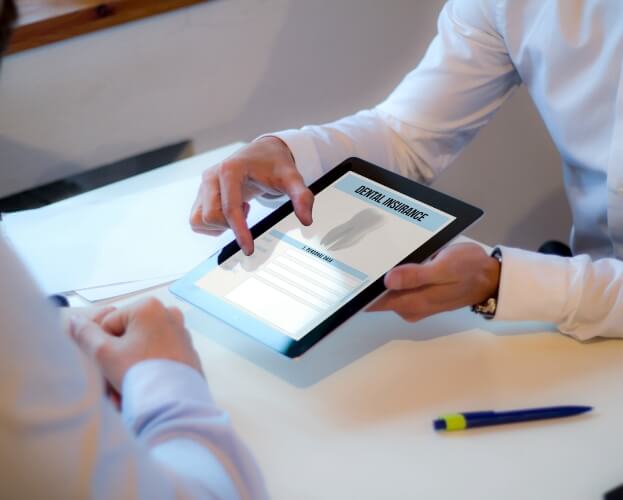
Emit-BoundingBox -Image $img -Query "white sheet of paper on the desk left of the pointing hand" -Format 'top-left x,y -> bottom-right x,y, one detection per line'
2,176 -> 271,293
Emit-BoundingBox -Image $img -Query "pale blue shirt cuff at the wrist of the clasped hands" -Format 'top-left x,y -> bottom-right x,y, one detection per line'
121,359 -> 216,434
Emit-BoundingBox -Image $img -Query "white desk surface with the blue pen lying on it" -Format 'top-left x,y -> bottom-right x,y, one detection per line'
69,146 -> 623,500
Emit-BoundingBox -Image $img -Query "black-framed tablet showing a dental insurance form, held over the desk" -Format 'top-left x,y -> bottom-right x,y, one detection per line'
170,158 -> 483,357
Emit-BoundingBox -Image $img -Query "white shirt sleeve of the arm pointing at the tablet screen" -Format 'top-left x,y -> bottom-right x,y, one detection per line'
270,0 -> 520,183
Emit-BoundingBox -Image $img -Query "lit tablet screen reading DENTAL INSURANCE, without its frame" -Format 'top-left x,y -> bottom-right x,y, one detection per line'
194,171 -> 455,340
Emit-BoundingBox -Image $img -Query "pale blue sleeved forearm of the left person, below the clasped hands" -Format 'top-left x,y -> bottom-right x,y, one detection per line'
122,360 -> 266,499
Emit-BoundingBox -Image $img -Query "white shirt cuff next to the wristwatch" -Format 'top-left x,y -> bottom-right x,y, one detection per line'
495,246 -> 569,324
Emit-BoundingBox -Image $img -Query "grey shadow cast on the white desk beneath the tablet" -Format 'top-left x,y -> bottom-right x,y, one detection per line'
184,307 -> 554,388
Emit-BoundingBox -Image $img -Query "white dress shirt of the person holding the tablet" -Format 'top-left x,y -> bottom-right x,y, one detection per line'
271,0 -> 623,339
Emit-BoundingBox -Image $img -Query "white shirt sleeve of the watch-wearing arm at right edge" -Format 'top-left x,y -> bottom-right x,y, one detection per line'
495,247 -> 623,340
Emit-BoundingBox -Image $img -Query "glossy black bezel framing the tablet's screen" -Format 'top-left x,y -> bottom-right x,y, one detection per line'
170,157 -> 484,358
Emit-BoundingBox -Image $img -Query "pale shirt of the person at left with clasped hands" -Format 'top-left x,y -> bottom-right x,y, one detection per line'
0,236 -> 266,500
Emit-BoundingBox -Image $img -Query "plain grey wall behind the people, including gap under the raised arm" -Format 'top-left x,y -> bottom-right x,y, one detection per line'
0,0 -> 569,248
